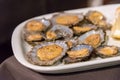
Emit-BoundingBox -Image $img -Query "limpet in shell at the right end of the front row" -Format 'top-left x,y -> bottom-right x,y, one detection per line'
96,45 -> 120,58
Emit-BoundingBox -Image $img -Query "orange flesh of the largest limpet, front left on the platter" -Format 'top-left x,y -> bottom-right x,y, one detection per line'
37,44 -> 63,61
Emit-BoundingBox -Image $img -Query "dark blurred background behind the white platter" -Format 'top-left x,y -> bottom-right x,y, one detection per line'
0,0 -> 120,63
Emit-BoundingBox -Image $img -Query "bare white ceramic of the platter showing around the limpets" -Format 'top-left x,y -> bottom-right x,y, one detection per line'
11,4 -> 120,73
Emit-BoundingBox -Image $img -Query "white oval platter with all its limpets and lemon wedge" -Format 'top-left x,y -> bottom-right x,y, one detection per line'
11,4 -> 120,74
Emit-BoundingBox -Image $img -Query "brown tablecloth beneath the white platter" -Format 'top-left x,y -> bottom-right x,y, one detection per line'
0,56 -> 120,80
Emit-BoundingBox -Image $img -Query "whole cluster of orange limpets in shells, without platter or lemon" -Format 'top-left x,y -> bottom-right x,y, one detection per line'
22,10 -> 120,66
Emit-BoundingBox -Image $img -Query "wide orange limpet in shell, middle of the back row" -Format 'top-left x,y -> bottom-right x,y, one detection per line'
51,13 -> 84,27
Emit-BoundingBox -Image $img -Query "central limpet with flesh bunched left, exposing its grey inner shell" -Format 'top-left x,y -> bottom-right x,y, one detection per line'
46,25 -> 73,40
